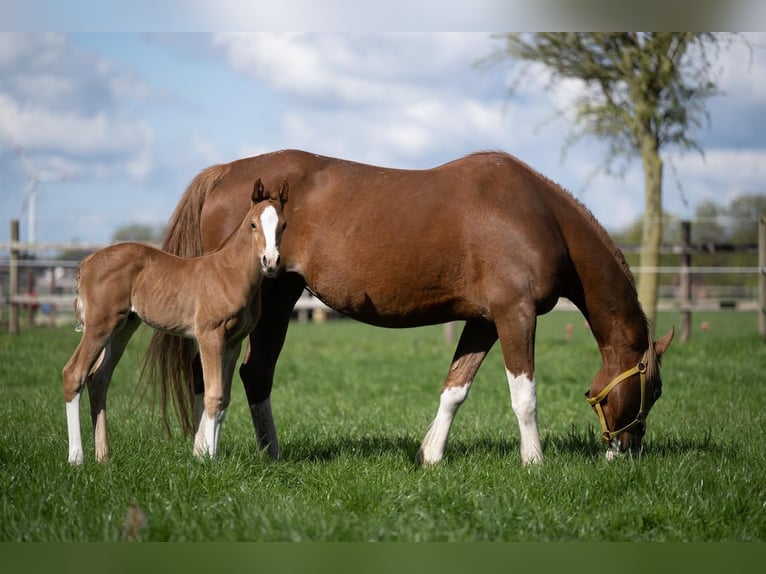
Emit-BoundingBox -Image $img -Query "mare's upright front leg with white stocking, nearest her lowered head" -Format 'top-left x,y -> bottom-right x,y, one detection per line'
493,305 -> 543,464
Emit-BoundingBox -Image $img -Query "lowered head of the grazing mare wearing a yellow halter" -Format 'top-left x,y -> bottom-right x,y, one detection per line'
585,329 -> 674,460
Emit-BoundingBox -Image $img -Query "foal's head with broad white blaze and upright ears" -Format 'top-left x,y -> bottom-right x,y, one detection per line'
250,178 -> 288,277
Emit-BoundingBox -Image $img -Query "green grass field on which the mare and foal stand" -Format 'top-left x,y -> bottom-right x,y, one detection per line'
0,312 -> 766,541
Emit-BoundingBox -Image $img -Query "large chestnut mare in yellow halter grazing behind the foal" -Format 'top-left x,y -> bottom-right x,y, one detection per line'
147,150 -> 673,465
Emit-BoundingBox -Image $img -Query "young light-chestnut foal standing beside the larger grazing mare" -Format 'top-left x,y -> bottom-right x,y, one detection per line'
63,179 -> 288,464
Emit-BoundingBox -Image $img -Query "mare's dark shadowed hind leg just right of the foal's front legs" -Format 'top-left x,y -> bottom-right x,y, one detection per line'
239,273 -> 305,459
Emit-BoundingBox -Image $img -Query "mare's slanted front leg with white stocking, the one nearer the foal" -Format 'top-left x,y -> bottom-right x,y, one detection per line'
417,320 -> 497,465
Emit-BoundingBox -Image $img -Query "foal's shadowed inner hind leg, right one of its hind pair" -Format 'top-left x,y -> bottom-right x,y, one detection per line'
87,315 -> 141,462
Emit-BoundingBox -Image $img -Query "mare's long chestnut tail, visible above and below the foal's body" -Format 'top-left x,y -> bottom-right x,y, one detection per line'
141,164 -> 230,435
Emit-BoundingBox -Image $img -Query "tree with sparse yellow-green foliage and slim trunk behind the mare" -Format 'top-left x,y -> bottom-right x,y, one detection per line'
488,32 -> 735,330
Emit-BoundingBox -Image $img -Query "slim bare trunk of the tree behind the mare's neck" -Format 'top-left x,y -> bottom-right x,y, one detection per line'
638,135 -> 662,330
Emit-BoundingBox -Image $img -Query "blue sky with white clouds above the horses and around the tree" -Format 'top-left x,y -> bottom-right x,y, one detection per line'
0,32 -> 766,248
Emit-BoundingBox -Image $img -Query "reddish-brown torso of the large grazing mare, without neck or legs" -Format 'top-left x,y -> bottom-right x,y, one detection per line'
202,150 -> 566,326
